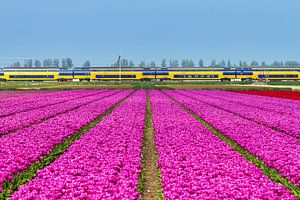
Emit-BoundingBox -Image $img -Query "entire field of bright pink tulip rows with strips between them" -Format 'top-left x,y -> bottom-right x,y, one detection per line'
0,90 -> 300,200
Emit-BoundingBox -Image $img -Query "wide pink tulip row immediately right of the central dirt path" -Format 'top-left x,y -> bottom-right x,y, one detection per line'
151,91 -> 294,199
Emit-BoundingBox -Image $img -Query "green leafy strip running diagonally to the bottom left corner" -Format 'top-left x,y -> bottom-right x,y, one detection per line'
0,92 -> 133,200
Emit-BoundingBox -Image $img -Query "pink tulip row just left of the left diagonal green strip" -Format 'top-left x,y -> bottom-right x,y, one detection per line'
0,91 -> 131,191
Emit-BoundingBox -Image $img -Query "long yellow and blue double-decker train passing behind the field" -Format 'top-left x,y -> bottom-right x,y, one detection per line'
0,67 -> 300,81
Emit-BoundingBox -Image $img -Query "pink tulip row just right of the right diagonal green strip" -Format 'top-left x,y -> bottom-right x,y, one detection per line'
166,91 -> 300,186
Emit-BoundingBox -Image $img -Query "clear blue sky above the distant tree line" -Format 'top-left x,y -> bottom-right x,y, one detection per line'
0,0 -> 300,65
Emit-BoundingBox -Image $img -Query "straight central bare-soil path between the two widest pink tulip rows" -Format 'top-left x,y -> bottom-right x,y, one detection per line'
138,91 -> 164,200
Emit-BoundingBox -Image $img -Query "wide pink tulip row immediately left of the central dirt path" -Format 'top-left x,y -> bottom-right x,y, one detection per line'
12,91 -> 146,199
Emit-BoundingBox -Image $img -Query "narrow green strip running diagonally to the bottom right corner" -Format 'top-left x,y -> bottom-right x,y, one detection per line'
163,92 -> 300,200
